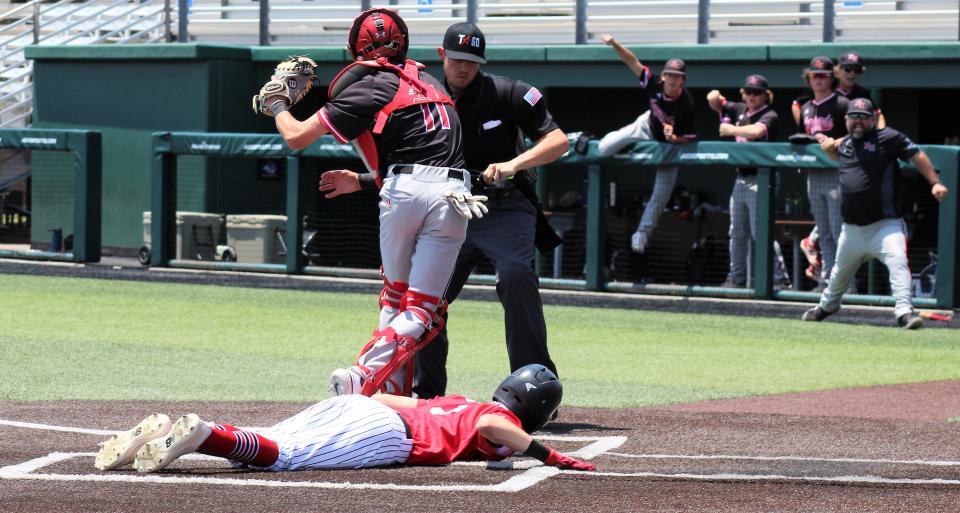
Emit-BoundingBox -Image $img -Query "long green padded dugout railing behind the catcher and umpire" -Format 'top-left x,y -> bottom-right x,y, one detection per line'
151,132 -> 960,308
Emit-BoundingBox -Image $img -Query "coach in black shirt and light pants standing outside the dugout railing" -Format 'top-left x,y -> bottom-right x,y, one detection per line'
803,98 -> 947,329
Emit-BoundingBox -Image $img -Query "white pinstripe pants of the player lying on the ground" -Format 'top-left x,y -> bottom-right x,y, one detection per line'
262,395 -> 413,471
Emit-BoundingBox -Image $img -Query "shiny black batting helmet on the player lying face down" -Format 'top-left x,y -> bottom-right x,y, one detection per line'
493,364 -> 563,433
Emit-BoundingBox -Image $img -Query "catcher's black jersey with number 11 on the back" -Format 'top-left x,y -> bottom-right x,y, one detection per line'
317,70 -> 465,173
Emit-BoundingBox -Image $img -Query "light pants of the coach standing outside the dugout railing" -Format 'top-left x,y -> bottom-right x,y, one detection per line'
820,218 -> 913,317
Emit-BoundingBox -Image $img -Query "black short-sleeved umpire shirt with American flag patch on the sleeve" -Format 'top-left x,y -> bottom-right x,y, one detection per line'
444,71 -> 559,181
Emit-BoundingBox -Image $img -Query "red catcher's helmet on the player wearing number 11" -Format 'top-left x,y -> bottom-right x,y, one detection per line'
347,7 -> 410,60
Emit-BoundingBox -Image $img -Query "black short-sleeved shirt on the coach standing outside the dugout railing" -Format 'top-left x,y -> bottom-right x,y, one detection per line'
838,128 -> 920,226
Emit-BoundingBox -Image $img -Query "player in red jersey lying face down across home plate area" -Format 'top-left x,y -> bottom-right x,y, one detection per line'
94,365 -> 596,472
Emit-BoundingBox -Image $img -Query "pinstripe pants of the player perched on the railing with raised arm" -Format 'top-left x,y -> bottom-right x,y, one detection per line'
597,110 -> 677,236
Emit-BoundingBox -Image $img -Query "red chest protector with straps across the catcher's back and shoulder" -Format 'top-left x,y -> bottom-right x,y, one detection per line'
327,57 -> 453,188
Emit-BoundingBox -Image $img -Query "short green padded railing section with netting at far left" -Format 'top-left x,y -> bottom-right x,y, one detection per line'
0,128 -> 102,262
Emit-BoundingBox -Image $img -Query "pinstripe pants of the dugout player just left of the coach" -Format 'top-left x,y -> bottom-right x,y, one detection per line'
807,169 -> 843,282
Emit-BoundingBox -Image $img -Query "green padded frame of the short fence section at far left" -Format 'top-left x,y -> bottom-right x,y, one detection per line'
0,128 -> 102,262
